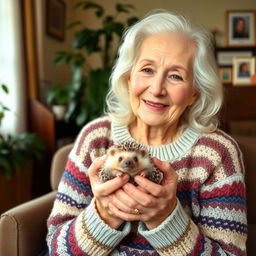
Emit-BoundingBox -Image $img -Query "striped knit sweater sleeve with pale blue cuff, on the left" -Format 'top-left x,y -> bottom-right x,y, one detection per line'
47,117 -> 131,256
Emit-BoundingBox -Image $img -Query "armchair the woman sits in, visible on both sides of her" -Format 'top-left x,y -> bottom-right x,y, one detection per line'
0,137 -> 256,256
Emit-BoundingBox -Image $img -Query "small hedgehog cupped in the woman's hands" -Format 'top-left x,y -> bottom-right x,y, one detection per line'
99,141 -> 163,184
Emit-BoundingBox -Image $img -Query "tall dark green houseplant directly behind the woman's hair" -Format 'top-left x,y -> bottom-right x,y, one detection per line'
54,1 -> 138,127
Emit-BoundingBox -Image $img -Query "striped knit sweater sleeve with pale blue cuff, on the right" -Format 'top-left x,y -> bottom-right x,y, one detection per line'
139,133 -> 247,256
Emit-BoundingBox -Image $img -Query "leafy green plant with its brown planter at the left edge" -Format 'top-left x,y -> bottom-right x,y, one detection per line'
0,84 -> 45,213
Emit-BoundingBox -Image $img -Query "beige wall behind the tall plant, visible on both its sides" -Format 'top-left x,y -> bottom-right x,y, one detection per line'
35,0 -> 256,102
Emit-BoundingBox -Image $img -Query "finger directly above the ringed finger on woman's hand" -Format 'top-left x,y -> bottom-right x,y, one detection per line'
123,183 -> 155,208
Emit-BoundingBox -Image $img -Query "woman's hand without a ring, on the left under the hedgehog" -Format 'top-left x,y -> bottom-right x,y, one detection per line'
88,156 -> 129,229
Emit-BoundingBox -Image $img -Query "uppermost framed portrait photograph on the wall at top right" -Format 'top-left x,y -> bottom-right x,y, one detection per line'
226,10 -> 256,47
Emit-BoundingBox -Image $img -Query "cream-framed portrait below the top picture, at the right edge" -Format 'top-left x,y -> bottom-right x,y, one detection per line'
233,57 -> 255,86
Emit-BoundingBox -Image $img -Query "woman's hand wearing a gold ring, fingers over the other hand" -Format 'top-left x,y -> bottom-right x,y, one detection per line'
109,158 -> 178,229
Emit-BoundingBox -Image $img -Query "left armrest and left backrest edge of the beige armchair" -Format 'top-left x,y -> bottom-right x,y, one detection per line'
0,145 -> 72,256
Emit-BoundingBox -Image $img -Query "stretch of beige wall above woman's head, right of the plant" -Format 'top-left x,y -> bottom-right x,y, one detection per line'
84,0 -> 256,46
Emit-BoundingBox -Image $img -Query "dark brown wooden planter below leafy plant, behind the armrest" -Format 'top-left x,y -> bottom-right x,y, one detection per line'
0,163 -> 32,214
